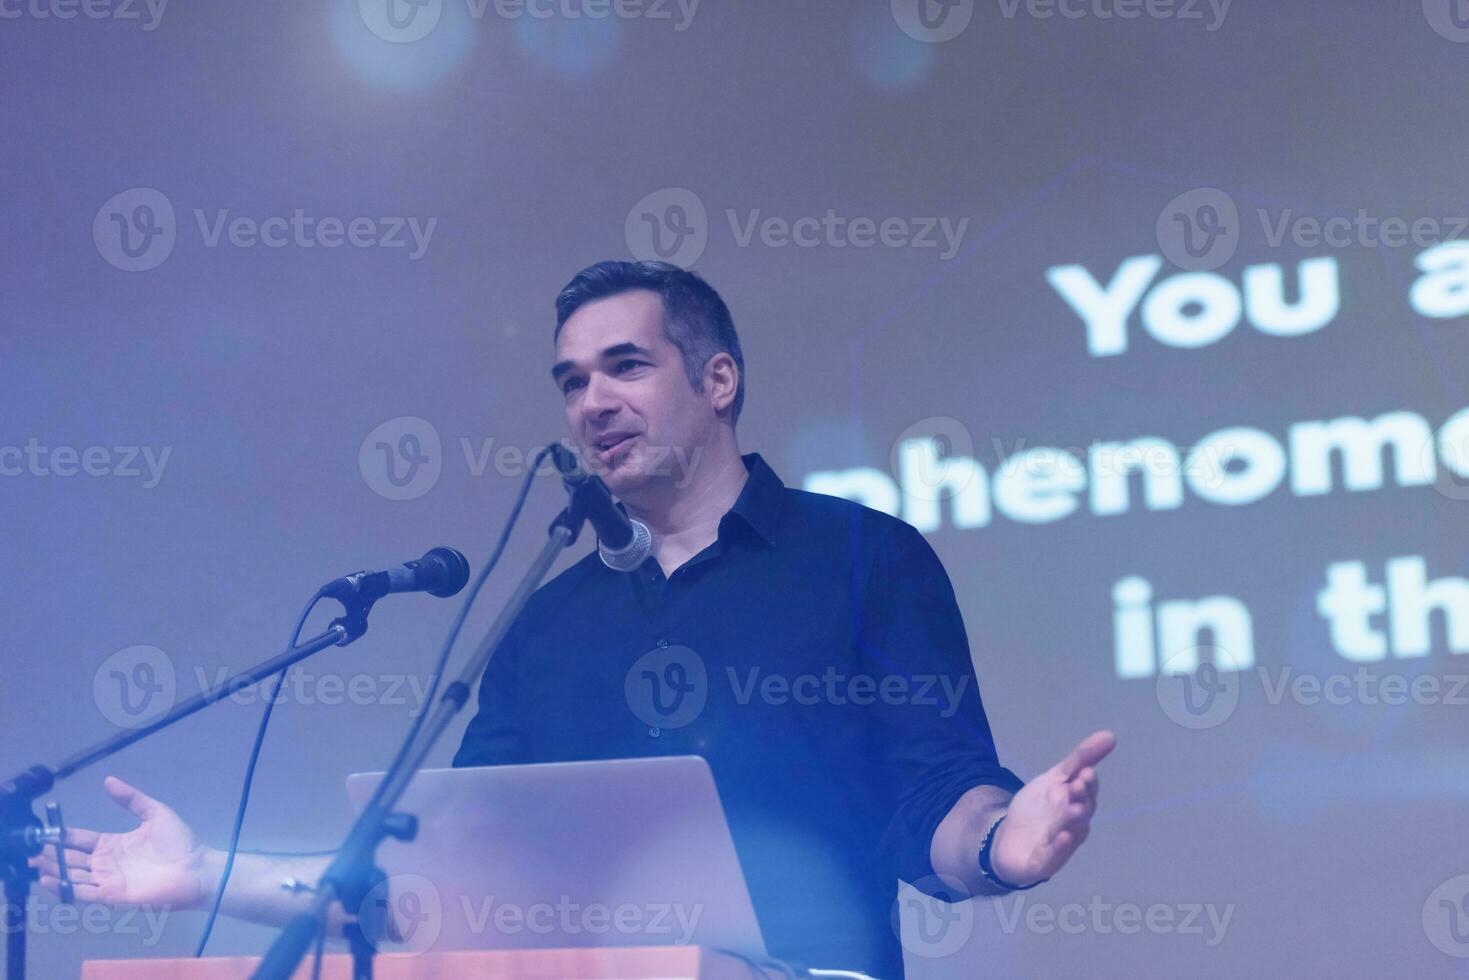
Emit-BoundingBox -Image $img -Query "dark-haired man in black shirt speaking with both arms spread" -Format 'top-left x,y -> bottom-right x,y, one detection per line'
38,262 -> 1115,977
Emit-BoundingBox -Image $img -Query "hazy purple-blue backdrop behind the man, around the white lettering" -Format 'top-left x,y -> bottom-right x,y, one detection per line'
0,0 -> 1469,979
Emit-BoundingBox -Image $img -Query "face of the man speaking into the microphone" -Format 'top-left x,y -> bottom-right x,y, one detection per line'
552,289 -> 715,497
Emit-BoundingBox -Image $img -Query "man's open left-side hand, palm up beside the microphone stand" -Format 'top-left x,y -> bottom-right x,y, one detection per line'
31,776 -> 209,909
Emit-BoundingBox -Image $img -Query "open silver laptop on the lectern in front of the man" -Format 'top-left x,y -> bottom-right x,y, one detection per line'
347,755 -> 765,956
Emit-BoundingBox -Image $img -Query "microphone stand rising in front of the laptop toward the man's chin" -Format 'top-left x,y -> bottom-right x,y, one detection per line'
251,478 -> 605,980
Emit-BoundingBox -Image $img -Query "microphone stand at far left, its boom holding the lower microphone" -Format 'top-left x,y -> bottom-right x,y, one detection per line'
0,597 -> 387,980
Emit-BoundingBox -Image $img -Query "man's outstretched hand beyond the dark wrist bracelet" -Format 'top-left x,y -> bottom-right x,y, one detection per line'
990,732 -> 1116,886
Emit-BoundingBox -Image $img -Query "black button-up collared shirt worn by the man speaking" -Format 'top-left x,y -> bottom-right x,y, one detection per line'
454,453 -> 1022,977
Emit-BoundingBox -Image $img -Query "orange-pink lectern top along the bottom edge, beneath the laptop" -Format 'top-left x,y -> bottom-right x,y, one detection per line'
82,946 -> 782,980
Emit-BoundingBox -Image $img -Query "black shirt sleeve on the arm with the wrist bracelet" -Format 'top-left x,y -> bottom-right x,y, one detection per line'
858,522 -> 1024,895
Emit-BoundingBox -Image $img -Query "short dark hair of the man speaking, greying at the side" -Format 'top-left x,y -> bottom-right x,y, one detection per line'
552,262 -> 745,423
